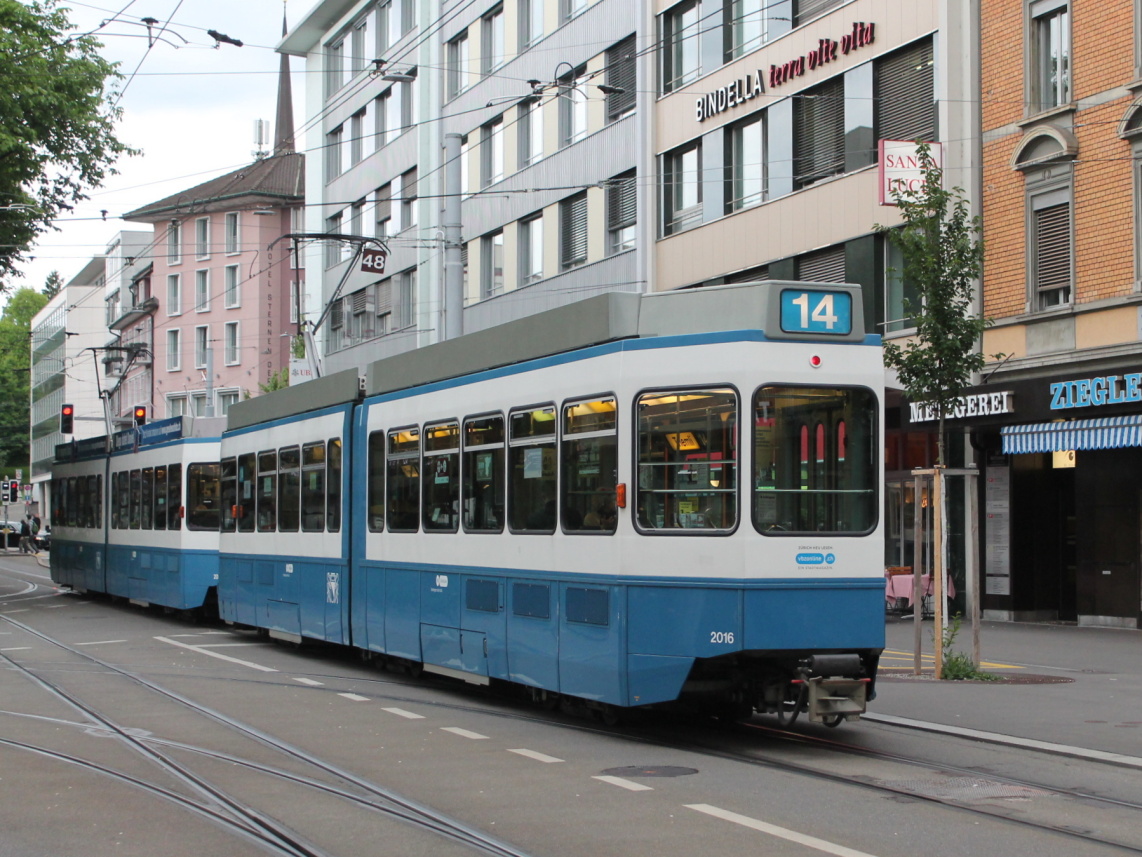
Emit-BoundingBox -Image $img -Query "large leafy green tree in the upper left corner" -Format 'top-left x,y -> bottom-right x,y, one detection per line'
0,0 -> 134,281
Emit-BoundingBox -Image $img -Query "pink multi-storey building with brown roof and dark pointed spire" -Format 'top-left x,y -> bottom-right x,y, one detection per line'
121,42 -> 305,419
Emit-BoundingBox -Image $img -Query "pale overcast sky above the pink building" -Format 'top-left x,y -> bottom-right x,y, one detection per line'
11,0 -> 317,290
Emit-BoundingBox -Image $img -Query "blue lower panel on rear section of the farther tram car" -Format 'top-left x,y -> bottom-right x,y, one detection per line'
106,545 -> 218,610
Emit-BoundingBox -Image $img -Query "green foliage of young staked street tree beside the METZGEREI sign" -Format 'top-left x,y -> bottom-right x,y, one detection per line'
876,143 -> 990,464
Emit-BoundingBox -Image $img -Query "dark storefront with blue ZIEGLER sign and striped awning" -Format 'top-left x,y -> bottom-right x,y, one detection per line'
954,367 -> 1142,627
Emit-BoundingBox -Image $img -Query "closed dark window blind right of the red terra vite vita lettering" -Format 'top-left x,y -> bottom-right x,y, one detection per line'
876,38 -> 935,141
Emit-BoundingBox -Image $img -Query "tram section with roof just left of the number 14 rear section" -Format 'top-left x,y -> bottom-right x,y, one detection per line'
219,370 -> 361,644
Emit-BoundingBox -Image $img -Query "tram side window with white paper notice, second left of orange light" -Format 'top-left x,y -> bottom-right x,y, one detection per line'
507,406 -> 557,532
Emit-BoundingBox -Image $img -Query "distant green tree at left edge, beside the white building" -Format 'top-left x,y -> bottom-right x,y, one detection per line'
0,288 -> 48,476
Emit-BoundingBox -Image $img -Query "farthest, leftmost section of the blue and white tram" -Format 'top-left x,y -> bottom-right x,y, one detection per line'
50,436 -> 107,592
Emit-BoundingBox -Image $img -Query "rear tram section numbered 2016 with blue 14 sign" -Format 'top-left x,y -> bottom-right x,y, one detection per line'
351,283 -> 884,724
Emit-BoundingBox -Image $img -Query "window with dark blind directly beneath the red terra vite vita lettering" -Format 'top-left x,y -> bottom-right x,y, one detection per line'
793,75 -> 845,187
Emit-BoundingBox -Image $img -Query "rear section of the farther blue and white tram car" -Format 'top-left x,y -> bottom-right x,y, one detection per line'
106,417 -> 225,612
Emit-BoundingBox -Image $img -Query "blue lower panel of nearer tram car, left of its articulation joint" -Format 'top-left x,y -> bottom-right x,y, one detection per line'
218,554 -> 349,644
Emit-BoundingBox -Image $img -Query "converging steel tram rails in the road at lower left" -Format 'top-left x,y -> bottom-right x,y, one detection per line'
0,616 -> 529,857
